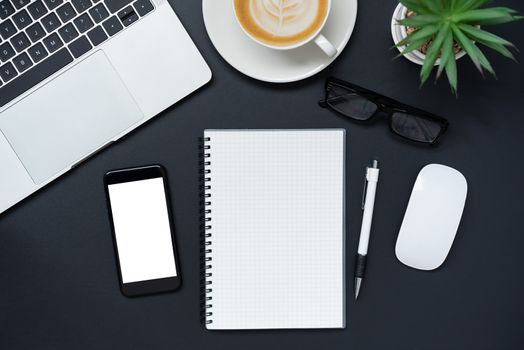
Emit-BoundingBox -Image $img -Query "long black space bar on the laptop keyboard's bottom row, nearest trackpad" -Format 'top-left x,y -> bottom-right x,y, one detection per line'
0,48 -> 73,107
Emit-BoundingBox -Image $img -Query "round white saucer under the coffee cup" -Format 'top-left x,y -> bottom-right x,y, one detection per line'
202,0 -> 357,83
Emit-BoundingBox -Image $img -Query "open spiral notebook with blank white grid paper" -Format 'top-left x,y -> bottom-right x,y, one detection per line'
201,129 -> 346,330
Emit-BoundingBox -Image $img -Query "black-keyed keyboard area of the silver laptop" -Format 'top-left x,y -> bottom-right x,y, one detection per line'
0,0 -> 154,107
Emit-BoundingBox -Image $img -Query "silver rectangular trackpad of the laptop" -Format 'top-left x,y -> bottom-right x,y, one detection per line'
0,51 -> 143,184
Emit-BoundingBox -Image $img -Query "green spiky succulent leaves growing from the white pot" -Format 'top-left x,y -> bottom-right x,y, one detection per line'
396,0 -> 524,94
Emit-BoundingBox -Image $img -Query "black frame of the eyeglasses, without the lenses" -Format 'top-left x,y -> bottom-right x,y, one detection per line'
318,77 -> 449,145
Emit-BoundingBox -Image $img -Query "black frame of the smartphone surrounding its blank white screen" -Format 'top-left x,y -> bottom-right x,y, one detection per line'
104,164 -> 182,297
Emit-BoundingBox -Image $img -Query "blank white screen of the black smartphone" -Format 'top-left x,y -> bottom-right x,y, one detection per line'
108,178 -> 177,283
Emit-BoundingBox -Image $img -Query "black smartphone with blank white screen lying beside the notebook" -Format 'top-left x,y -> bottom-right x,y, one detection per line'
104,165 -> 182,297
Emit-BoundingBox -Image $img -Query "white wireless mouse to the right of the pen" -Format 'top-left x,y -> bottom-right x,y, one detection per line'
395,164 -> 468,270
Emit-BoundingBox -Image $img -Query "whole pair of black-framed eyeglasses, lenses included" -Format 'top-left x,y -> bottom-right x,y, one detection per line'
319,78 -> 449,145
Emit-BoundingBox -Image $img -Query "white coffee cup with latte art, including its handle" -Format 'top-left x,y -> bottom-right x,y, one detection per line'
232,0 -> 337,57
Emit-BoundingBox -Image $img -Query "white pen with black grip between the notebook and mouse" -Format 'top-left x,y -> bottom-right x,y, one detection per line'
355,160 -> 380,300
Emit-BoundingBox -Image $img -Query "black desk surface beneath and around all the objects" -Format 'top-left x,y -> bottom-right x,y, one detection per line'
0,0 -> 524,350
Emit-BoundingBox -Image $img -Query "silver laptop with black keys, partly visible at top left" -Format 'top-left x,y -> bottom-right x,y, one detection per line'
0,0 -> 211,213
